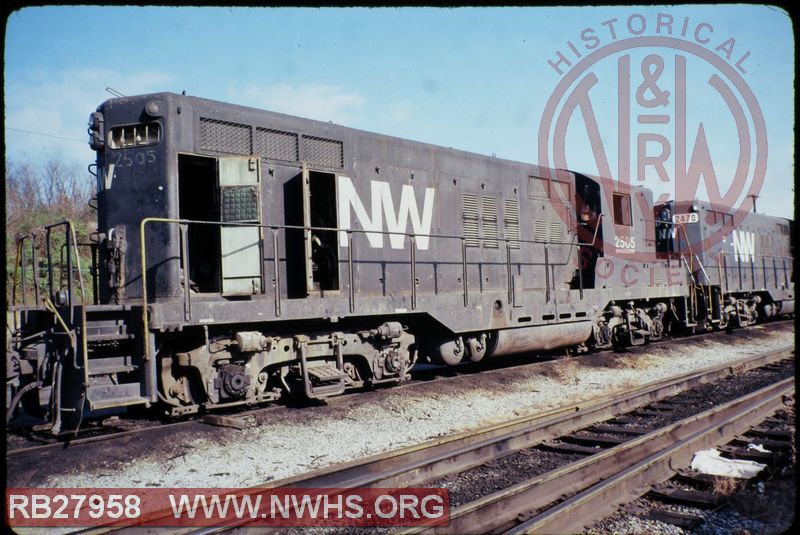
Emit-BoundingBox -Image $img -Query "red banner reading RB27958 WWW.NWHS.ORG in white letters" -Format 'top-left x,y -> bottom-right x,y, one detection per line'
6,488 -> 449,527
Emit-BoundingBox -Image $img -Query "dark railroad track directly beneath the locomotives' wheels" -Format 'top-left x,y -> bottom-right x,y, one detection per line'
6,320 -> 784,459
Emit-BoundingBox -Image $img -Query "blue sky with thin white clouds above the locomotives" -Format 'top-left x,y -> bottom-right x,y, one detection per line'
4,5 -> 794,217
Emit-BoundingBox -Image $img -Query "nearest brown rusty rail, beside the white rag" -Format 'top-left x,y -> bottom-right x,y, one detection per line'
434,364 -> 794,533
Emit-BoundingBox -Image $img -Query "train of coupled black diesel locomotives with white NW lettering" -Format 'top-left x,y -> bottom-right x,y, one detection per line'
7,93 -> 794,432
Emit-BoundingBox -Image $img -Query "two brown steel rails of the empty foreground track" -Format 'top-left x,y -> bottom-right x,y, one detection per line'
97,348 -> 794,534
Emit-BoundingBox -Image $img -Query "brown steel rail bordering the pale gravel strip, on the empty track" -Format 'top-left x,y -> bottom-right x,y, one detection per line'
87,347 -> 794,535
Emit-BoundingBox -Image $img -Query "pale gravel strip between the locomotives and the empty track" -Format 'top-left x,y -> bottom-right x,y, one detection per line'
14,322 -> 794,488
